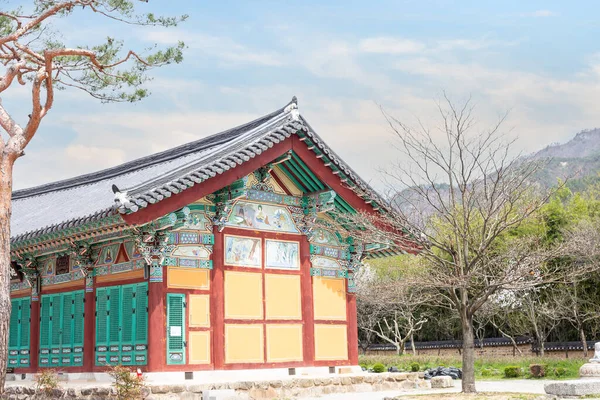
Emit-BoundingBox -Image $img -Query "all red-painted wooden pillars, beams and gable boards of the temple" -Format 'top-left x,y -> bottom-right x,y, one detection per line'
12,135 -> 376,372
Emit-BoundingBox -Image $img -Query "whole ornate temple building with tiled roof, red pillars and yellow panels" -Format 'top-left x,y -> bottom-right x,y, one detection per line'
9,98 -> 398,375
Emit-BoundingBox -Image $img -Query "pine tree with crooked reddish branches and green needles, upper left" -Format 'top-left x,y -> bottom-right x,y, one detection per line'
0,0 -> 186,391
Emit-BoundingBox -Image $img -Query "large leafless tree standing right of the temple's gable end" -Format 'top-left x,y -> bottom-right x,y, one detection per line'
339,96 -> 592,392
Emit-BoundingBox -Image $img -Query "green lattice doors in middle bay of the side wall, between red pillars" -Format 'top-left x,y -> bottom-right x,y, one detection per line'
39,290 -> 85,367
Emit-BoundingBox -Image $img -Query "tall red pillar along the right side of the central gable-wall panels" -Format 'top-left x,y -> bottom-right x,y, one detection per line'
300,236 -> 315,365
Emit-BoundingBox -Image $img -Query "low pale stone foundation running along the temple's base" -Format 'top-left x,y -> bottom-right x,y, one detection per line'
1,372 -> 431,400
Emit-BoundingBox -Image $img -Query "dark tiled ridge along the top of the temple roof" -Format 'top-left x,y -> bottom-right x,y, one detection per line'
12,100 -> 297,200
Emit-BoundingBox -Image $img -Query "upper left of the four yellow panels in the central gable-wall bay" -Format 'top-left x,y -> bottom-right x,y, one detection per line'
225,271 -> 263,319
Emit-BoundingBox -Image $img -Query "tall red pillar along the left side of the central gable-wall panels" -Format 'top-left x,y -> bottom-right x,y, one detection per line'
210,226 -> 225,369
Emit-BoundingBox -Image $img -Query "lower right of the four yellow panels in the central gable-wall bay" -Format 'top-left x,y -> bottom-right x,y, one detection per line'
267,324 -> 304,362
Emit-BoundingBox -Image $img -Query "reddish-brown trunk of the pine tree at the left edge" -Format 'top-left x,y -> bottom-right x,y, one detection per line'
0,155 -> 12,393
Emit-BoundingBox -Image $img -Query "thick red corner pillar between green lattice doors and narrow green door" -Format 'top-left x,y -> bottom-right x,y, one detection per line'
148,266 -> 167,372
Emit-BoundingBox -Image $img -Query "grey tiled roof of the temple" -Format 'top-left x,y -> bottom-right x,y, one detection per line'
11,98 -> 382,243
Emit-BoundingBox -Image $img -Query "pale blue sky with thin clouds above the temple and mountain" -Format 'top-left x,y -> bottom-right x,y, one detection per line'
7,0 -> 600,188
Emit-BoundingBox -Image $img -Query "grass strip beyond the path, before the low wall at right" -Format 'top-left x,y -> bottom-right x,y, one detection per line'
358,355 -> 587,380
